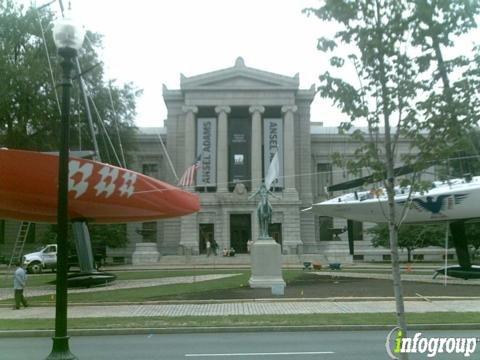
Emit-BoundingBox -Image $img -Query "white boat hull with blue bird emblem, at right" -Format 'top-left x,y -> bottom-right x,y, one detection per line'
312,176 -> 480,223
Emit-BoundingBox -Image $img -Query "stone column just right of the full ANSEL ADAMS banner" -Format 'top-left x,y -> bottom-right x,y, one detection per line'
215,106 -> 230,192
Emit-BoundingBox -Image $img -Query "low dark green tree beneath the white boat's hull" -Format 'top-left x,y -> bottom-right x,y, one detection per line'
368,223 -> 446,262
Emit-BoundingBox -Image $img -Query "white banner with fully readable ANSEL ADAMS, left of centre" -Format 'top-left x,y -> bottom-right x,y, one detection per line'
197,118 -> 217,186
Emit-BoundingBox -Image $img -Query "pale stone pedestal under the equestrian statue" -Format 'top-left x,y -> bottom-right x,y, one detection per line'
248,238 -> 285,295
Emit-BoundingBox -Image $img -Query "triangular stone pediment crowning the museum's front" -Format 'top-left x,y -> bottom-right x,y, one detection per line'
180,58 -> 299,91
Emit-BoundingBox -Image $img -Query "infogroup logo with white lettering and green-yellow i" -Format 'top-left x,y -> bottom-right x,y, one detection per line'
385,327 -> 479,359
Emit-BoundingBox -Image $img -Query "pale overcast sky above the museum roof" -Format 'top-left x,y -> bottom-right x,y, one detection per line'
65,0 -> 341,127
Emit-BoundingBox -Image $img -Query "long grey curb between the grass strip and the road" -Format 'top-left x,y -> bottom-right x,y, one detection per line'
0,324 -> 480,338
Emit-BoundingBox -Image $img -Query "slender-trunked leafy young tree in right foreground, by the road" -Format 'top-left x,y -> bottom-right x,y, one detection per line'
306,0 -> 478,346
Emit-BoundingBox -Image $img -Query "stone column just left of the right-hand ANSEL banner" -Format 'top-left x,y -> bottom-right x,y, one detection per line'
249,105 -> 265,191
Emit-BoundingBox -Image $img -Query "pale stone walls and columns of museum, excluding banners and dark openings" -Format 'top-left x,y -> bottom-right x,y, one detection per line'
120,58 -> 450,262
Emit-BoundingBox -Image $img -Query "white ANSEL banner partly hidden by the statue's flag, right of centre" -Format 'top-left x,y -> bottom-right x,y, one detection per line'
263,119 -> 283,187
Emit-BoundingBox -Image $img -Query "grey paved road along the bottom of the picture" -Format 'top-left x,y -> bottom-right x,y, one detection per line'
0,331 -> 480,360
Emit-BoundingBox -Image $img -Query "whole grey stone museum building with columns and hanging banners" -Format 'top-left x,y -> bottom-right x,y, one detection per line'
0,58 -> 450,264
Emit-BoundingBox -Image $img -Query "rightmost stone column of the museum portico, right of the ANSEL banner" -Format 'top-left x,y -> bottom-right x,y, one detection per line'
282,105 -> 297,193
